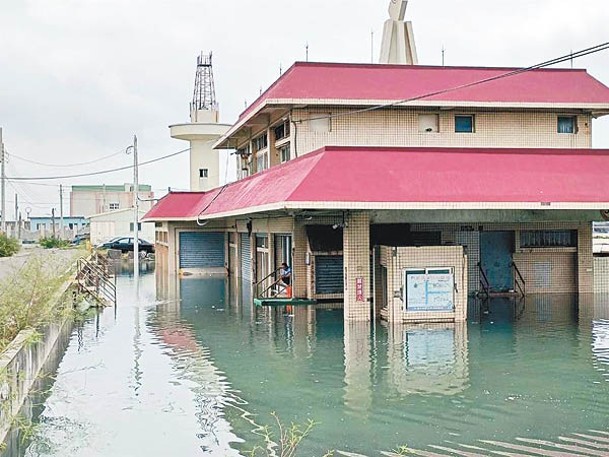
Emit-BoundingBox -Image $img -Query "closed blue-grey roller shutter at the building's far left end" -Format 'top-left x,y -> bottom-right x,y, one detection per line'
180,232 -> 224,268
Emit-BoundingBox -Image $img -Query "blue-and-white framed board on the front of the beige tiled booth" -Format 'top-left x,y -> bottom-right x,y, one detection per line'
403,268 -> 455,311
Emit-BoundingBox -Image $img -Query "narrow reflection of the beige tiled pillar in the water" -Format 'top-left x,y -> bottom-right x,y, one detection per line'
343,322 -> 372,415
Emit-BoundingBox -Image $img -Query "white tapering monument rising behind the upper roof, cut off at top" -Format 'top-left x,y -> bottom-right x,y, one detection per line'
380,0 -> 417,65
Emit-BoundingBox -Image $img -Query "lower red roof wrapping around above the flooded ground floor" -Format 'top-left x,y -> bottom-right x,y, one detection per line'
145,147 -> 609,220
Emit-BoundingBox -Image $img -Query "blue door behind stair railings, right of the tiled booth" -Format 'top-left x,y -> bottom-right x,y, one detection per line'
480,232 -> 514,291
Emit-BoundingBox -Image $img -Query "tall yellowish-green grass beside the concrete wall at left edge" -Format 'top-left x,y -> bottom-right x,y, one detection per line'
0,256 -> 71,351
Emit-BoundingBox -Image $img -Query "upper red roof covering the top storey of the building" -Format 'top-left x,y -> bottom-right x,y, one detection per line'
239,62 -> 609,120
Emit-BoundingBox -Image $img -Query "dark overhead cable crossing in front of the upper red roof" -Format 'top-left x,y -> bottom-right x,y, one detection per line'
293,42 -> 609,124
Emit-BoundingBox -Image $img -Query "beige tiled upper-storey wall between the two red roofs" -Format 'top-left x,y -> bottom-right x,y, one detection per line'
293,108 -> 592,155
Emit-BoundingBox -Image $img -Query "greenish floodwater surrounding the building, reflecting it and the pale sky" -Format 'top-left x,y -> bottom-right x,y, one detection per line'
4,275 -> 609,457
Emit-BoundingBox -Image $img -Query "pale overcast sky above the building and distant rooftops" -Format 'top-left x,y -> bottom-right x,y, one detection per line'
0,0 -> 609,218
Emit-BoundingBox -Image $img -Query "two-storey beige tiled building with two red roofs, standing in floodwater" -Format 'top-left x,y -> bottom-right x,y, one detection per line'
146,63 -> 609,321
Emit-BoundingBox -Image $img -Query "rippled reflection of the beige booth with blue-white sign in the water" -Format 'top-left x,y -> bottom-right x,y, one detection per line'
387,323 -> 469,395
